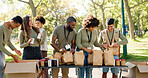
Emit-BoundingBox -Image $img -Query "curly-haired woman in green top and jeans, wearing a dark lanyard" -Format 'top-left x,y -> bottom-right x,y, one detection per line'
76,15 -> 107,78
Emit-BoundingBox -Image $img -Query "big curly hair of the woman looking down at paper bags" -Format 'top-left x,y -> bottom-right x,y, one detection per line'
82,15 -> 99,28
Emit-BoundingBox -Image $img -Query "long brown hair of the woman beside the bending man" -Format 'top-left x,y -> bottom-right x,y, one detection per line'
20,15 -> 39,39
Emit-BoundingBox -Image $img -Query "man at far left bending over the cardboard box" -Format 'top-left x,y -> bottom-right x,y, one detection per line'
0,16 -> 22,78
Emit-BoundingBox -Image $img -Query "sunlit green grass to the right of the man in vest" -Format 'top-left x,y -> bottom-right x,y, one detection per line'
121,32 -> 148,62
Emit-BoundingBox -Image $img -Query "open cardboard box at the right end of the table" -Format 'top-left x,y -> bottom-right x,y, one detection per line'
126,62 -> 148,78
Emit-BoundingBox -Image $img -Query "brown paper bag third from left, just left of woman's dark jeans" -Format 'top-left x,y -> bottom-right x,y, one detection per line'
74,51 -> 85,65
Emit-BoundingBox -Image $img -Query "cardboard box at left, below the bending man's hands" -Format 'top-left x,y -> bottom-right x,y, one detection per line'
4,60 -> 40,78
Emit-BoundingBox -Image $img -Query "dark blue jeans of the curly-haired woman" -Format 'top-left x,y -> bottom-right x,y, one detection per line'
78,51 -> 92,78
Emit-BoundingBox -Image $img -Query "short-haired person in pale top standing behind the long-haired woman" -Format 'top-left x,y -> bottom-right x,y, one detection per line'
34,16 -> 48,58
